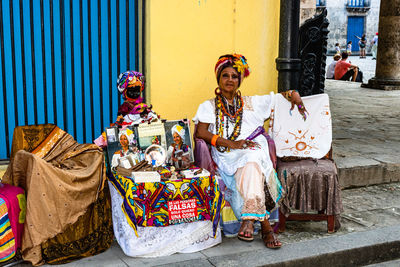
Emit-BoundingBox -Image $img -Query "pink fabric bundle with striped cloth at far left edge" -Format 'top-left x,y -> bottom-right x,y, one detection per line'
0,184 -> 26,262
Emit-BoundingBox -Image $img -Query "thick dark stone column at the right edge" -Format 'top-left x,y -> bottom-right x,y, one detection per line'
362,0 -> 400,90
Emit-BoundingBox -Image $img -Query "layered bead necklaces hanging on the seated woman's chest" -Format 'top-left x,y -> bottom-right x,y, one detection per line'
215,92 -> 243,152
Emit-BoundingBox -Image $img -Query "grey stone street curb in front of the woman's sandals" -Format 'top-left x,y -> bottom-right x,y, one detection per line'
162,225 -> 400,267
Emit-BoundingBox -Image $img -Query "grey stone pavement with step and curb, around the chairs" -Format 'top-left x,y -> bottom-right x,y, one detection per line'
5,77 -> 400,266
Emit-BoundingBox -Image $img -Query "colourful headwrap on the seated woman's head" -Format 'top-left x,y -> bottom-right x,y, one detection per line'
215,54 -> 250,84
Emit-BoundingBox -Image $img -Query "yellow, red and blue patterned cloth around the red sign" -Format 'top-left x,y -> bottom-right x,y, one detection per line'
108,173 -> 224,238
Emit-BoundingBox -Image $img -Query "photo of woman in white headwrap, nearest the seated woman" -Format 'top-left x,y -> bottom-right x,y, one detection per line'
164,119 -> 194,169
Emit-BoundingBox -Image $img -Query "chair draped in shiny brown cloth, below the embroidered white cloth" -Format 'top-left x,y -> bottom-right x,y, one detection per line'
277,155 -> 342,233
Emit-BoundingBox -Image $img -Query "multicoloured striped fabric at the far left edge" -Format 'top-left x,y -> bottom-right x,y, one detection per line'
0,198 -> 16,262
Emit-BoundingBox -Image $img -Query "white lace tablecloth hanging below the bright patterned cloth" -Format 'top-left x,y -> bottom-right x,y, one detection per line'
109,182 -> 221,257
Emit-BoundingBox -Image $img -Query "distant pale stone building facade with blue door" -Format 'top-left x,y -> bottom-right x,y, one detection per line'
316,0 -> 380,54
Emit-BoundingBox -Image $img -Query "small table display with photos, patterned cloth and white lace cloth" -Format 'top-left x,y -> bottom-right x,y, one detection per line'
101,121 -> 224,257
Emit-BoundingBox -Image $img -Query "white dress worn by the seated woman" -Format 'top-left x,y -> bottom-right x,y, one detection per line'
193,93 -> 276,221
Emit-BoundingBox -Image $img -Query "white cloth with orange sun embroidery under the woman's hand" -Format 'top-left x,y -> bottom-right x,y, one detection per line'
270,94 -> 332,159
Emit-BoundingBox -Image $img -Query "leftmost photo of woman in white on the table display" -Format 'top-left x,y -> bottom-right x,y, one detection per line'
106,126 -> 143,170
